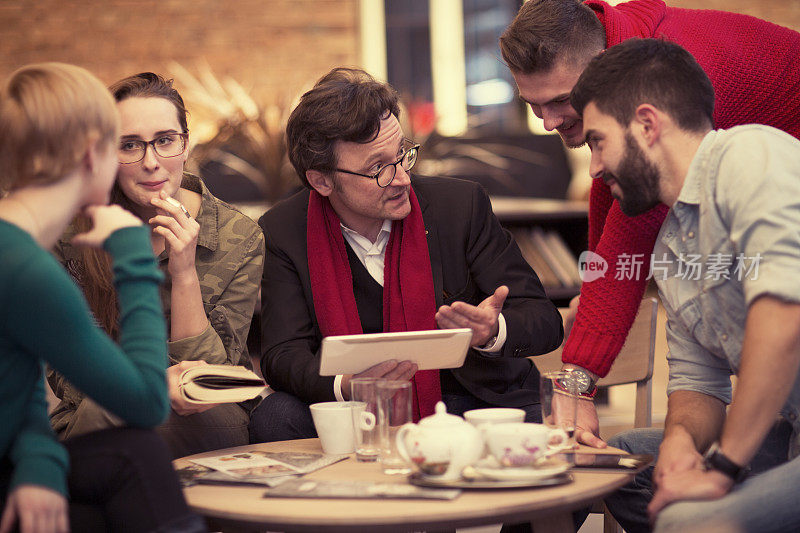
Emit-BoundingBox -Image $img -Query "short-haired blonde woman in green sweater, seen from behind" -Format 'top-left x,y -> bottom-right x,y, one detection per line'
0,63 -> 205,533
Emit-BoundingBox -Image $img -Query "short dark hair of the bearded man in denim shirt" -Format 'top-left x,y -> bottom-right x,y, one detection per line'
570,39 -> 714,132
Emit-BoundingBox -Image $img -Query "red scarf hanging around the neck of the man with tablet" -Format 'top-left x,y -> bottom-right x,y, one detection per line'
306,189 -> 442,421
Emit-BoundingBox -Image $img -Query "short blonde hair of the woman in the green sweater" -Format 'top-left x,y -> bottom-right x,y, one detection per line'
0,63 -> 119,191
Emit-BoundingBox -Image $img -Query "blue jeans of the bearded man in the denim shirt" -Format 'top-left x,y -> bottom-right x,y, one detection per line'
606,422 -> 800,533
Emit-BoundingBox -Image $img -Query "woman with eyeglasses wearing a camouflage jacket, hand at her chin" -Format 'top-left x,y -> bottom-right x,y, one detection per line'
48,72 -> 264,457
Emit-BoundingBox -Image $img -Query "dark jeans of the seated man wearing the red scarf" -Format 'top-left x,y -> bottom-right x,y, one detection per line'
250,391 -> 542,444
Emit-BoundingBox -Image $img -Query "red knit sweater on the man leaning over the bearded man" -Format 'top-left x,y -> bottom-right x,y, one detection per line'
563,0 -> 800,376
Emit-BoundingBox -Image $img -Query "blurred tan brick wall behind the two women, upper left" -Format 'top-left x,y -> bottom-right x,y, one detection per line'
0,0 -> 359,103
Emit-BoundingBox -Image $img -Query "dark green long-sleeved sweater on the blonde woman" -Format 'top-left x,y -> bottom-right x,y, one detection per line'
0,220 -> 169,494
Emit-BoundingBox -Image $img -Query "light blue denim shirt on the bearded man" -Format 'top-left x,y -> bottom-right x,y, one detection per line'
651,125 -> 800,456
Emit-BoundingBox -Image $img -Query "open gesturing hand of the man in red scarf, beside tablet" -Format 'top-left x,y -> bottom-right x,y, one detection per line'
436,285 -> 508,347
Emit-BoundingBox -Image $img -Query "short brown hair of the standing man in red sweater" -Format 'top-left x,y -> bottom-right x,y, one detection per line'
500,0 -> 606,74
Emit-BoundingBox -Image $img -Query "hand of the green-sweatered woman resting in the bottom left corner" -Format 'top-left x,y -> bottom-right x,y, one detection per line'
0,485 -> 69,533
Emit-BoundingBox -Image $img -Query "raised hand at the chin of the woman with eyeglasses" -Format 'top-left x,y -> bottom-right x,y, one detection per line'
147,192 -> 200,282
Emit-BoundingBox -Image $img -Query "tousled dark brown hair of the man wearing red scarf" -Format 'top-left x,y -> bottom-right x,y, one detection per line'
286,67 -> 400,187
